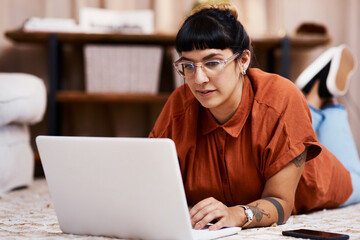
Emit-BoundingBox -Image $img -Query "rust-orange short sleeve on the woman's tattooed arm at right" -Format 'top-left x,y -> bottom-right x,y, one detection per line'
258,79 -> 321,179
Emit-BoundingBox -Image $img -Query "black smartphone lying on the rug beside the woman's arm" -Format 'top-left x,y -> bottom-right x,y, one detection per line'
282,229 -> 349,240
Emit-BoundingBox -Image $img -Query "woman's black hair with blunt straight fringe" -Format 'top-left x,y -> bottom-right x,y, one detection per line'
176,8 -> 252,57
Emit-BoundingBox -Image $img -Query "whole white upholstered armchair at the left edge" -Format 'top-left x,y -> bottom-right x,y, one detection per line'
0,73 -> 46,194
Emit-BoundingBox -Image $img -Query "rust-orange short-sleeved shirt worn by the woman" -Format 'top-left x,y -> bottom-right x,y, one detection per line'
149,69 -> 352,213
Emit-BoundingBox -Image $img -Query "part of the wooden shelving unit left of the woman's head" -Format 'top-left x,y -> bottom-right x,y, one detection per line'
5,30 -> 175,135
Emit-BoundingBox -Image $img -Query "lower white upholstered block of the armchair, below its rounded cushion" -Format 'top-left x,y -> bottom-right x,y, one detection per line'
0,124 -> 34,194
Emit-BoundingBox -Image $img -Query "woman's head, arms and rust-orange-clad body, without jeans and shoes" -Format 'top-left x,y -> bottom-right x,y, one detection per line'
149,4 -> 358,230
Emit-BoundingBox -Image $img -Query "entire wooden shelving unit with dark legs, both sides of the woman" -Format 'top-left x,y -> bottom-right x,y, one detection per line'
5,30 -> 330,138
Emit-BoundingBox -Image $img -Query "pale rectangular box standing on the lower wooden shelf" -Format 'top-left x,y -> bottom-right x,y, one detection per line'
84,44 -> 163,94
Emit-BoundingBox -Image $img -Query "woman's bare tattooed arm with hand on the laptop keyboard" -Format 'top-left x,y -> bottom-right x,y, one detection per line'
190,149 -> 307,230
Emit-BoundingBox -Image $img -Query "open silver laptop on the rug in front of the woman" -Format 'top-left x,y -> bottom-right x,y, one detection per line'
36,136 -> 241,240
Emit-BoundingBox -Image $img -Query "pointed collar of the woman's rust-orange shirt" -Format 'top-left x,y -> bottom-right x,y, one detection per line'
200,75 -> 254,138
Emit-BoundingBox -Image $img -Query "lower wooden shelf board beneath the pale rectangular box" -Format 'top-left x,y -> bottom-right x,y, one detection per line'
56,91 -> 170,104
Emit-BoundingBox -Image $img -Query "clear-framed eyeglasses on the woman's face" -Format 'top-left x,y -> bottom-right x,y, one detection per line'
173,53 -> 239,78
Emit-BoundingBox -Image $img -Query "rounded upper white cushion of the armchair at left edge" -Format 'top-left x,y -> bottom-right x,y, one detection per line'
0,73 -> 46,126
